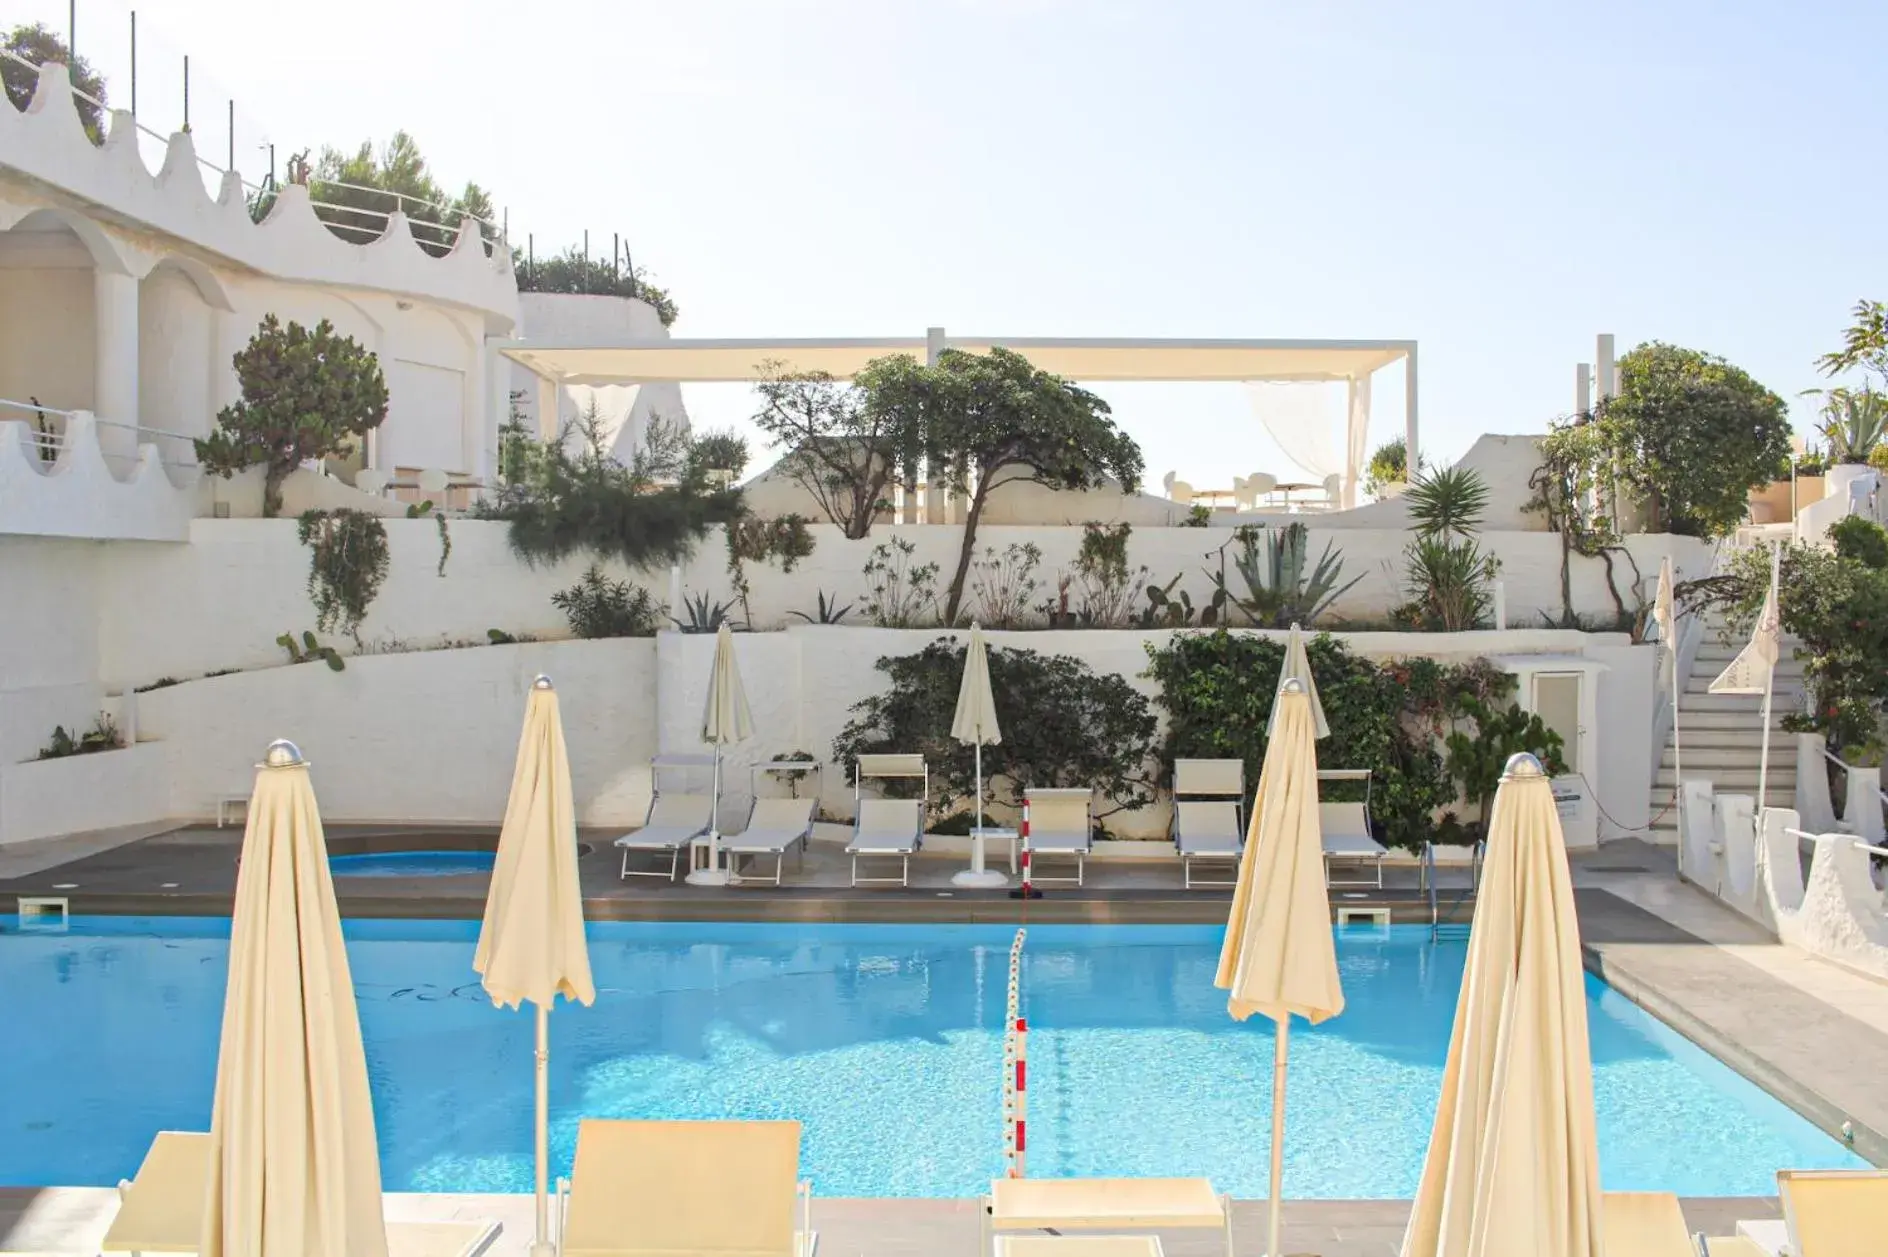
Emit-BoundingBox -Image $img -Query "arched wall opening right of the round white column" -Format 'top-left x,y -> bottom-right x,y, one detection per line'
138,257 -> 228,479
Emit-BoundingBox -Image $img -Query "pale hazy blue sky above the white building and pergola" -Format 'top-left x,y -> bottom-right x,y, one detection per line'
18,0 -> 1888,487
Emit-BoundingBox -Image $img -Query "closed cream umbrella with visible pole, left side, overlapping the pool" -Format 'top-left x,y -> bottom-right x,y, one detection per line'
472,676 -> 597,1257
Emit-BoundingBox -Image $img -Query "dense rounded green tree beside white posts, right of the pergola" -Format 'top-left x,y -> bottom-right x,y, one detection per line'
1593,342 -> 1790,536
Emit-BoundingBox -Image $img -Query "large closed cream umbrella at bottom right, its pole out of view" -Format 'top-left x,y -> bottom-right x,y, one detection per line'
1403,755 -> 1605,1257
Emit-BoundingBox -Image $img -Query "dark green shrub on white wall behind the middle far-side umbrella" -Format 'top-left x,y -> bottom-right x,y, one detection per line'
833,638 -> 1155,815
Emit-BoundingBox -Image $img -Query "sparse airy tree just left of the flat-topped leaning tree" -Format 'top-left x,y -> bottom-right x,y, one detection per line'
753,357 -> 918,540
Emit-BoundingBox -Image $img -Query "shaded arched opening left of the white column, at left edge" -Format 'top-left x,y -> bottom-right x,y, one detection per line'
0,210 -> 96,451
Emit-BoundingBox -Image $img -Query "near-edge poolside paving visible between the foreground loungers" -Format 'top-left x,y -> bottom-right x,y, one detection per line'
0,1187 -> 1778,1257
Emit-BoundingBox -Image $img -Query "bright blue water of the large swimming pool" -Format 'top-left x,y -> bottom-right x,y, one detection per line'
0,917 -> 1860,1198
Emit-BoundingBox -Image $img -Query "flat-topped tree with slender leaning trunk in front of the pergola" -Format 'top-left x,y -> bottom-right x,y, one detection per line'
857,347 -> 1142,625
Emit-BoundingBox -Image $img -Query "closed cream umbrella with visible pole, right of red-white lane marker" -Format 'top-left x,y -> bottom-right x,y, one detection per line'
1214,678 -> 1344,1257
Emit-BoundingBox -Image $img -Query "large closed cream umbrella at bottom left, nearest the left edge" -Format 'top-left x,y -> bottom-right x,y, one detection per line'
200,742 -> 387,1257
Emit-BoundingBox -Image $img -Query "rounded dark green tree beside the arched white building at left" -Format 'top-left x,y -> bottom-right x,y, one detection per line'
196,315 -> 387,519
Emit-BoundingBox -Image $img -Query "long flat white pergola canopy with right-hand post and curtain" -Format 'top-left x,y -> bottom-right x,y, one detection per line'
498,328 -> 1418,506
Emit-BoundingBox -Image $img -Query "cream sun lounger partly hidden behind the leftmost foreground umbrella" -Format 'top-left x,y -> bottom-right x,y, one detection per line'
100,1131 -> 498,1257
